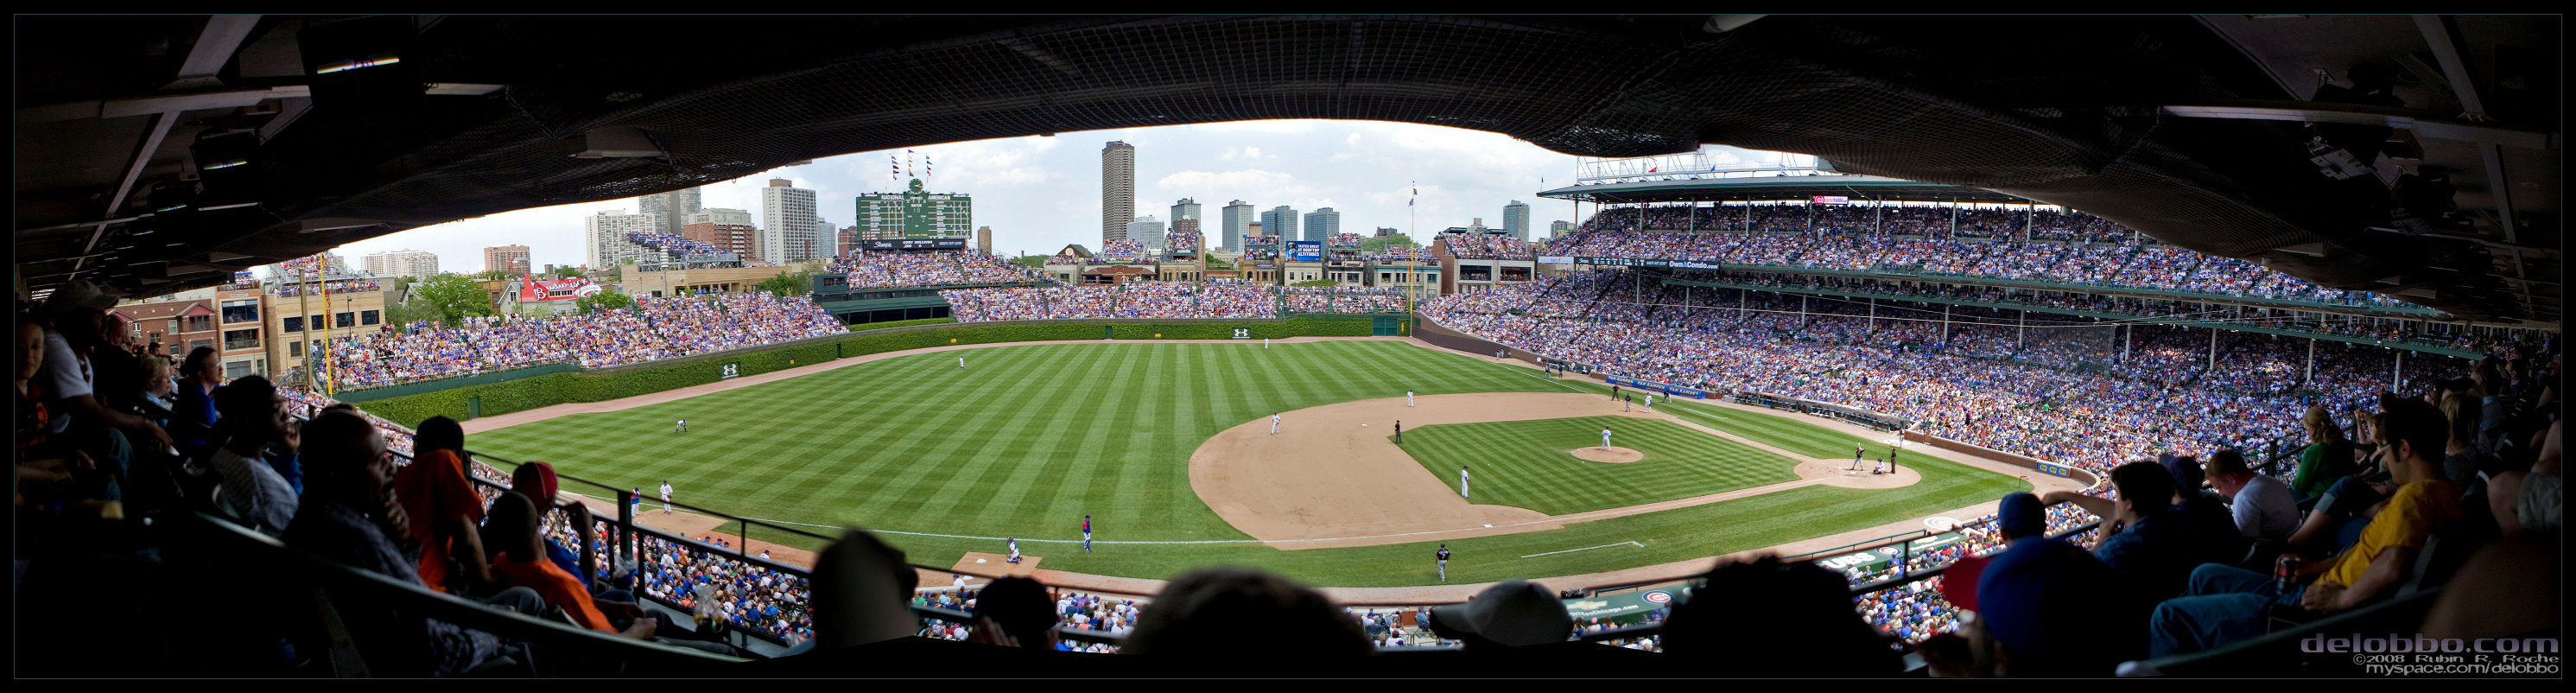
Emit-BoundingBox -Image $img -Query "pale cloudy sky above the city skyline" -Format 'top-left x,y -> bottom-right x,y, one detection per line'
311,121 -> 1780,273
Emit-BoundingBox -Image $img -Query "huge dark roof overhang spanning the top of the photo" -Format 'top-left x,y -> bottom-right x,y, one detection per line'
16,16 -> 2560,322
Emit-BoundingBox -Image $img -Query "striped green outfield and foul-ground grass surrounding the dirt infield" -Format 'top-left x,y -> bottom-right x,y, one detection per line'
469,343 -> 2027,588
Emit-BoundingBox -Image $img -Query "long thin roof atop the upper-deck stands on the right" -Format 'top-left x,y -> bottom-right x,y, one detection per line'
1538,175 -> 2027,204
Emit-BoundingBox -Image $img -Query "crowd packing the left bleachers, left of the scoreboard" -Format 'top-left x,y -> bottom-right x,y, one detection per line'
322,291 -> 847,389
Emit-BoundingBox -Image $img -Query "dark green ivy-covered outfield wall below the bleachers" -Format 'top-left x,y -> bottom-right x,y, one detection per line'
353,317 -> 1370,425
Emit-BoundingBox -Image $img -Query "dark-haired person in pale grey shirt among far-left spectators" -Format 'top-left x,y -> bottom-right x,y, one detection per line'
206,376 -> 301,536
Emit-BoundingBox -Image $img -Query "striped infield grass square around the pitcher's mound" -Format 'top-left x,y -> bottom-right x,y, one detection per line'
1404,417 -> 1798,515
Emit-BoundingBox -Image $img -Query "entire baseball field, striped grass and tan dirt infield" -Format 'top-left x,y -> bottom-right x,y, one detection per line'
466,340 -> 2030,588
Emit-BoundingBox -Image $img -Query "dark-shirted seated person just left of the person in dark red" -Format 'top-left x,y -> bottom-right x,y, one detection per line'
286,412 -> 541,675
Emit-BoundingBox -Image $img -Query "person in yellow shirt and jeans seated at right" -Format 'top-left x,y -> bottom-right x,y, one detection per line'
2148,397 -> 2460,657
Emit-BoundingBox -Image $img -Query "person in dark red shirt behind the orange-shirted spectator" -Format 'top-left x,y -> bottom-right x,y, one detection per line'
394,417 -> 495,595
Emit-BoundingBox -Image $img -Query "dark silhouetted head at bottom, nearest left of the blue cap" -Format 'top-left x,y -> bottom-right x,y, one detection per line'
1664,556 -> 1904,675
